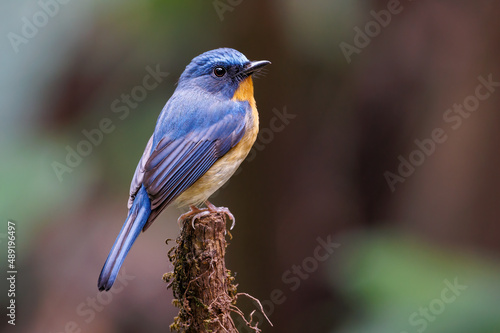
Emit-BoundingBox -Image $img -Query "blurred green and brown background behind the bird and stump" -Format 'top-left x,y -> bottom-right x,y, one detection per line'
0,0 -> 500,333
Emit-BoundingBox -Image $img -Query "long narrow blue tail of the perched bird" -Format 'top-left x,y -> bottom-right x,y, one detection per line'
97,186 -> 151,291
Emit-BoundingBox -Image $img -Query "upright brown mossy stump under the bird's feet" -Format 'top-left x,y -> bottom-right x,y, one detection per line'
163,213 -> 238,332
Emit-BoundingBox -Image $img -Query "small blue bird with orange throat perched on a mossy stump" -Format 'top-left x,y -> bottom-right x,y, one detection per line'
98,48 -> 271,291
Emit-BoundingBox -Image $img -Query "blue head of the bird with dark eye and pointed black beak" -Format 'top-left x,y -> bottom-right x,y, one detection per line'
179,48 -> 270,98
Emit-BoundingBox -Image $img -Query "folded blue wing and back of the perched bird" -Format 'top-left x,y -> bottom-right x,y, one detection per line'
131,96 -> 250,230
